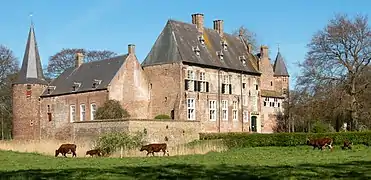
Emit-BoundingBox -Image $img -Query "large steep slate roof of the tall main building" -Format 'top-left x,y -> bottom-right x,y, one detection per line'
142,20 -> 261,74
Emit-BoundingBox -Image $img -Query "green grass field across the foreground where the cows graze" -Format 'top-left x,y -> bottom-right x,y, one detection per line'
0,145 -> 371,180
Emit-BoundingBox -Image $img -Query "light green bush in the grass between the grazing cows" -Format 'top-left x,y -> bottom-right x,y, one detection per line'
95,131 -> 144,155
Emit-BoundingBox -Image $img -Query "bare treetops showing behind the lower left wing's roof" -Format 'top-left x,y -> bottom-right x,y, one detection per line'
46,49 -> 117,78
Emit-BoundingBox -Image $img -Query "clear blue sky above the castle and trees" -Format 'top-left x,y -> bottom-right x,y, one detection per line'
0,0 -> 371,88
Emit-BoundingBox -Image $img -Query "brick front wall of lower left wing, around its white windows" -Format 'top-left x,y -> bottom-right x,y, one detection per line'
40,90 -> 108,140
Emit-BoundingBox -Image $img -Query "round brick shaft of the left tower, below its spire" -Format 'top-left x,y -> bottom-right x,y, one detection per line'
12,84 -> 46,139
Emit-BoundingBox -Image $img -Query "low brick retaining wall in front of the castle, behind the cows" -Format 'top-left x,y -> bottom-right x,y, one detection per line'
72,119 -> 200,145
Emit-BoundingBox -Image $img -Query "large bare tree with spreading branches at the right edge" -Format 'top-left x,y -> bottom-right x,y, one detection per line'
299,15 -> 371,129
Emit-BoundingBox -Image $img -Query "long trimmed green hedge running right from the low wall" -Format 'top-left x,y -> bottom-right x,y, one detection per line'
200,131 -> 371,148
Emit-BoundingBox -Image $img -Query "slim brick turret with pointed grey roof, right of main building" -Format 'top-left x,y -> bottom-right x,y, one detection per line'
273,49 -> 290,98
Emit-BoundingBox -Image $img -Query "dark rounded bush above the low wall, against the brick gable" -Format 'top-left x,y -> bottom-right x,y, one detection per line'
95,100 -> 130,119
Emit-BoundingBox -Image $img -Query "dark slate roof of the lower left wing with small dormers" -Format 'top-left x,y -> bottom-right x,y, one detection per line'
41,54 -> 128,97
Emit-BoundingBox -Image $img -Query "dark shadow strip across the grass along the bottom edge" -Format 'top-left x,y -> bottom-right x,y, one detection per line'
0,161 -> 371,180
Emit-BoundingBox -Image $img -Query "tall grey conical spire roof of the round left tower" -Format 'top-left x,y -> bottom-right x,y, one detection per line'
15,22 -> 48,84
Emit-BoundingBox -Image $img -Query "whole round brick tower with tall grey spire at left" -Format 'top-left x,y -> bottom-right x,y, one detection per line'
12,23 -> 48,140
